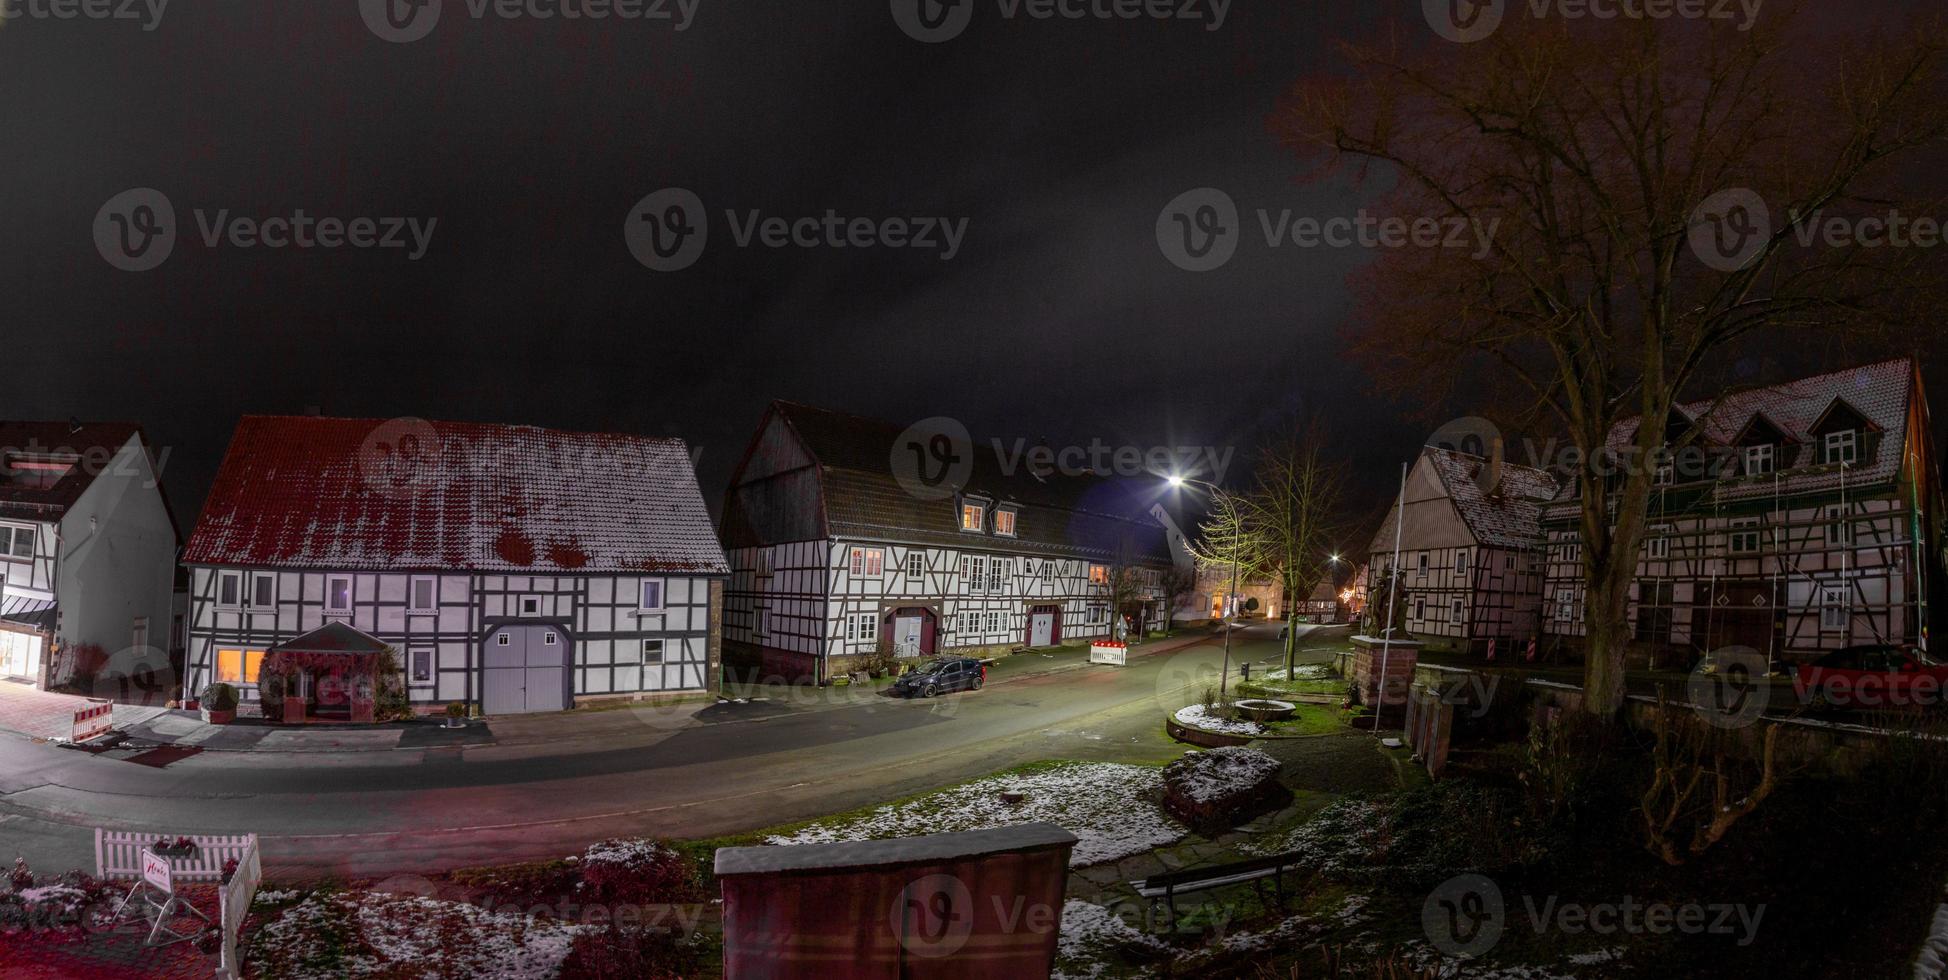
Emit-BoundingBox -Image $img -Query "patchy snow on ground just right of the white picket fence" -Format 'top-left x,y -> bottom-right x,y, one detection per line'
249,892 -> 581,980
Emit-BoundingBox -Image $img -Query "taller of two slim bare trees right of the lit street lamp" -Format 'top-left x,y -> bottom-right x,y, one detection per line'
1247,423 -> 1344,670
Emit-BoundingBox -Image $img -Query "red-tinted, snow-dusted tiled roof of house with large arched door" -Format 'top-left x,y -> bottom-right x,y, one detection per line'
183,415 -> 729,575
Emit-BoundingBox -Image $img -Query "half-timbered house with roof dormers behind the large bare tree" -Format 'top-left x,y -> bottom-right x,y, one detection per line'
1543,358 -> 1942,660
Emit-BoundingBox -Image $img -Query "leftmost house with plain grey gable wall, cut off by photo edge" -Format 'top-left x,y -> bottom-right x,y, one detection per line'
0,421 -> 181,697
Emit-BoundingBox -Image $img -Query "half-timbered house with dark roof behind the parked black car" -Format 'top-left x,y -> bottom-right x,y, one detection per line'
723,401 -> 1190,678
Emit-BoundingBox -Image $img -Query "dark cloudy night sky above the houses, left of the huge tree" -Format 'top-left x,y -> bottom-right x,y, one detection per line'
0,0 -> 1932,549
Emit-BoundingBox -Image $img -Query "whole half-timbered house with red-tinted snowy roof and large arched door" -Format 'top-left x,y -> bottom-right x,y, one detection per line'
183,417 -> 729,717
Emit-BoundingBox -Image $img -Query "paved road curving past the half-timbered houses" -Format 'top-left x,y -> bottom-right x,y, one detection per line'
0,625 -> 1348,877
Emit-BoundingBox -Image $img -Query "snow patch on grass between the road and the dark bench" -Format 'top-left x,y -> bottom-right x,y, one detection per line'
766,762 -> 1184,867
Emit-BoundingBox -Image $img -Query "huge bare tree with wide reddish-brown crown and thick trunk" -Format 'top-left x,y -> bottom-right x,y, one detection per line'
1274,4 -> 1948,717
